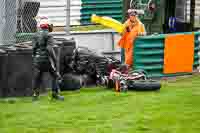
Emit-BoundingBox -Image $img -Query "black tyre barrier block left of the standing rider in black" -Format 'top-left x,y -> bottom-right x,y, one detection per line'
0,47 -> 32,97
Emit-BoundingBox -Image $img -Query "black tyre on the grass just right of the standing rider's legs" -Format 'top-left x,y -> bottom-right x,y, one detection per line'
60,74 -> 81,91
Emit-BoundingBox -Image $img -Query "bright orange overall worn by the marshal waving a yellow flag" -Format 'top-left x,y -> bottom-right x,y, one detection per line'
118,18 -> 146,66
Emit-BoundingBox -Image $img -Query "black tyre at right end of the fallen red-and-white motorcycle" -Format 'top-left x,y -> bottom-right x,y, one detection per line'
128,80 -> 161,91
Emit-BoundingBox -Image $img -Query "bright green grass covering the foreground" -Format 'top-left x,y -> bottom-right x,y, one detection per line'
0,76 -> 200,133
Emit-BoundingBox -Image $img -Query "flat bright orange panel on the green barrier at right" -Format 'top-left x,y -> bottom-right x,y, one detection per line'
163,34 -> 194,74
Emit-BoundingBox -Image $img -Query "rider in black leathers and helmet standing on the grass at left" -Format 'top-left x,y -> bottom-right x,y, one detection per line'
32,24 -> 64,100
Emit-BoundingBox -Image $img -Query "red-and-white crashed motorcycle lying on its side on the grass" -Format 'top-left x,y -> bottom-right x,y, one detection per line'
109,69 -> 161,92
